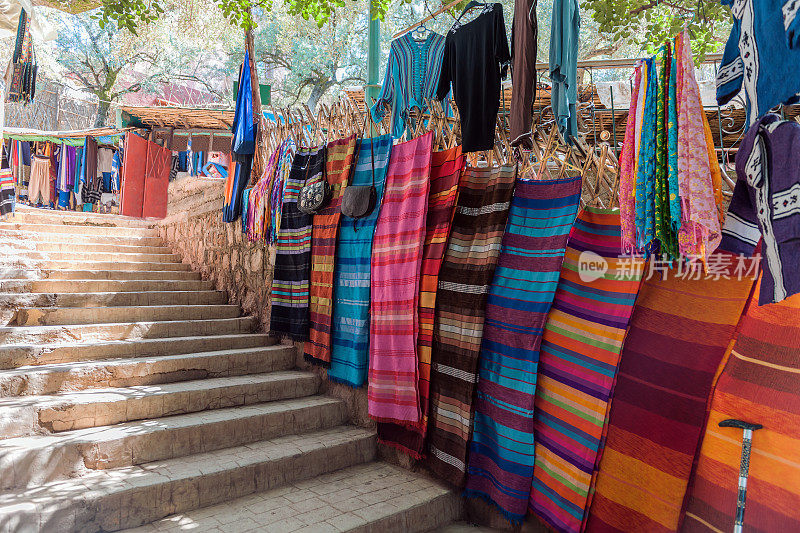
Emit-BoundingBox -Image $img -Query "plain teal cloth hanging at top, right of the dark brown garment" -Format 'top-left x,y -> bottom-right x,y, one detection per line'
550,0 -> 581,143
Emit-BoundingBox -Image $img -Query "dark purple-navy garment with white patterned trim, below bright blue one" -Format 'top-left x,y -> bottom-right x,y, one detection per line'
721,114 -> 800,305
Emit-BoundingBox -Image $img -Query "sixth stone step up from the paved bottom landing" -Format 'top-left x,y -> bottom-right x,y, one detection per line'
0,317 -> 256,344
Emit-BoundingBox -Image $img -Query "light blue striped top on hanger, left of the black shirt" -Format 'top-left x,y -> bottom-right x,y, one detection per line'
370,32 -> 449,138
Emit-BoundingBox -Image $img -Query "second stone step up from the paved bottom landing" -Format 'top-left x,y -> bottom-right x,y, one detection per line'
0,396 -> 347,490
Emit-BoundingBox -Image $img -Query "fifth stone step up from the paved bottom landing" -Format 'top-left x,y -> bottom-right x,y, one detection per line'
0,333 -> 275,370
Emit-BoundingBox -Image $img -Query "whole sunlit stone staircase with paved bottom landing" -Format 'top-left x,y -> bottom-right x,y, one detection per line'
0,207 -> 461,533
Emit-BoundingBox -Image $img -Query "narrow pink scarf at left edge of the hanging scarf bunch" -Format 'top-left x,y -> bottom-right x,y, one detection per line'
619,64 -> 643,254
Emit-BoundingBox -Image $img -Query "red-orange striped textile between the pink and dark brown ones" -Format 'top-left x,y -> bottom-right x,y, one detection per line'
378,146 -> 466,459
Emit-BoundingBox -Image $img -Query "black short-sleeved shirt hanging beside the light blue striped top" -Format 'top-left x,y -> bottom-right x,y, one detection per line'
436,4 -> 511,152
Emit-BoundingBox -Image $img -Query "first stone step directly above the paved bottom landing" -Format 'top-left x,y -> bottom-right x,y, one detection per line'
0,427 -> 376,533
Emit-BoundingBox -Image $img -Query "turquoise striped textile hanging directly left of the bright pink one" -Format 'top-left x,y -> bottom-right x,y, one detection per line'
328,135 -> 392,387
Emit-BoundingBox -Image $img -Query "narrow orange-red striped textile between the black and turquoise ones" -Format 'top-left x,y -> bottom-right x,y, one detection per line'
305,135 -> 356,367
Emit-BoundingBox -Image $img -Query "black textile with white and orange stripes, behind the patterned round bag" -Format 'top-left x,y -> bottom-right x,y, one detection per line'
270,148 -> 325,341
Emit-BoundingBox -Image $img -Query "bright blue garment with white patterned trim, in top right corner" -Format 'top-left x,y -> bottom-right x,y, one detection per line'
717,0 -> 800,127
